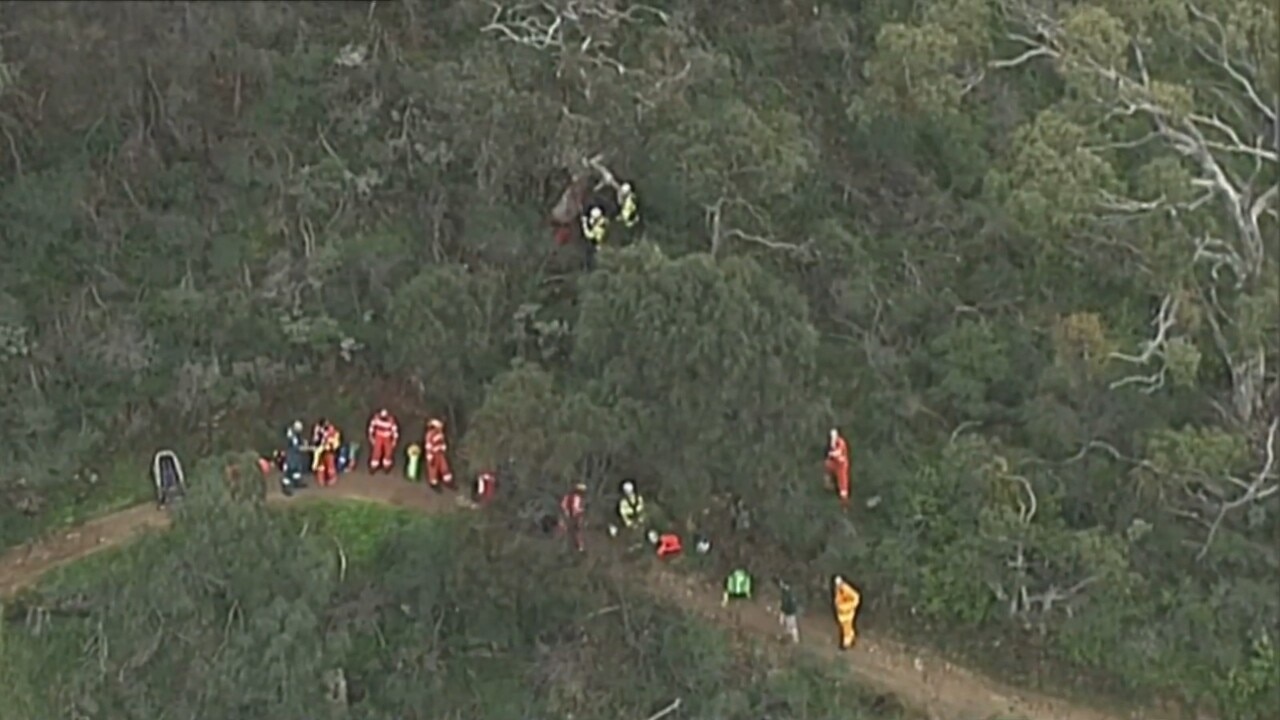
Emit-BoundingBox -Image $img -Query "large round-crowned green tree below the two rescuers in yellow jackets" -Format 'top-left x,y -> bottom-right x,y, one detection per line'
573,245 -> 823,514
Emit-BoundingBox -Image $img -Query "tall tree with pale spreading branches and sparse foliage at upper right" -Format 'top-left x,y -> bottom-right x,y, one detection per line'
993,0 -> 1280,424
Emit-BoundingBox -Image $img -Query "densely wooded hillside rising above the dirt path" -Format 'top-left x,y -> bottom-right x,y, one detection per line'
0,0 -> 1280,720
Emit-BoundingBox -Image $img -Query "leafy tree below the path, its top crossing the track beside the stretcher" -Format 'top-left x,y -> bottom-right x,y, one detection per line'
58,459 -> 343,717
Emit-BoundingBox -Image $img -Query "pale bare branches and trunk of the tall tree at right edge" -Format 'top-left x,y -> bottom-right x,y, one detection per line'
989,0 -> 1280,423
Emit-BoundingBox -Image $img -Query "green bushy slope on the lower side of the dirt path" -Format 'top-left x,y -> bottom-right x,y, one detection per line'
0,466 -> 916,720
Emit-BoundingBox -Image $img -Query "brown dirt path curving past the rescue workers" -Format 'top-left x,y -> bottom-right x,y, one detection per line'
0,473 -> 1166,720
